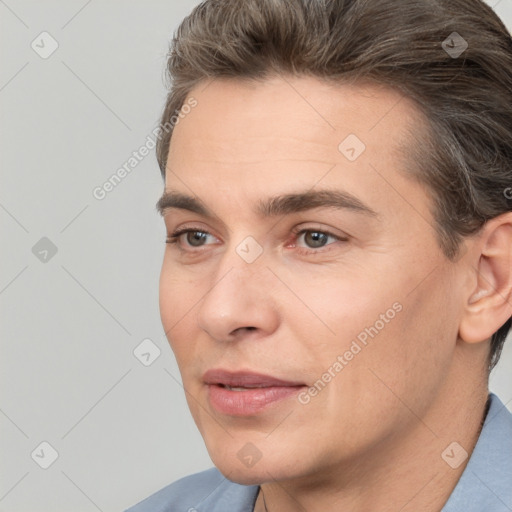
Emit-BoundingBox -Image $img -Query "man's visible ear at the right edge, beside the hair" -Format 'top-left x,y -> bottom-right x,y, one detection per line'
459,212 -> 512,343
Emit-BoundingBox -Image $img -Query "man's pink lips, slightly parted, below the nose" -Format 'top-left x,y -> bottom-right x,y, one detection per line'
203,369 -> 306,416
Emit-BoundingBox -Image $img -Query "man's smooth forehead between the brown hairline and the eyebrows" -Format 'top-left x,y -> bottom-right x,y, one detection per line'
166,76 -> 427,226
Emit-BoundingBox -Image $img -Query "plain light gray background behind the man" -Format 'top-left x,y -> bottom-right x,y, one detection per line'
0,0 -> 512,512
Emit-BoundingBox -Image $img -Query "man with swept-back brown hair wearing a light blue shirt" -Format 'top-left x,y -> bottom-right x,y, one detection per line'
126,0 -> 512,512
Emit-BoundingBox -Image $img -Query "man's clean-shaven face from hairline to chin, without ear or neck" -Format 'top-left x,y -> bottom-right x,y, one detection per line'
160,77 -> 463,484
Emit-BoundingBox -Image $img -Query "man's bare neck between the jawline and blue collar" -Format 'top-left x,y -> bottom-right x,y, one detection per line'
254,382 -> 488,512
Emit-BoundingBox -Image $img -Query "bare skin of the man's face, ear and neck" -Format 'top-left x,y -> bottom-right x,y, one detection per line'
160,77 -> 512,512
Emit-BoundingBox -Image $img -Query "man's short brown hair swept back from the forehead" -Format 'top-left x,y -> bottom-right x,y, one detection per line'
157,0 -> 512,369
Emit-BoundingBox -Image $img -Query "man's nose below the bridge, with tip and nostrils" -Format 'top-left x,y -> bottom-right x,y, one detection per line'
197,246 -> 279,341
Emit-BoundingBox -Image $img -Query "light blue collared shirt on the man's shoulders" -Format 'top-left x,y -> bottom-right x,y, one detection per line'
125,393 -> 512,512
